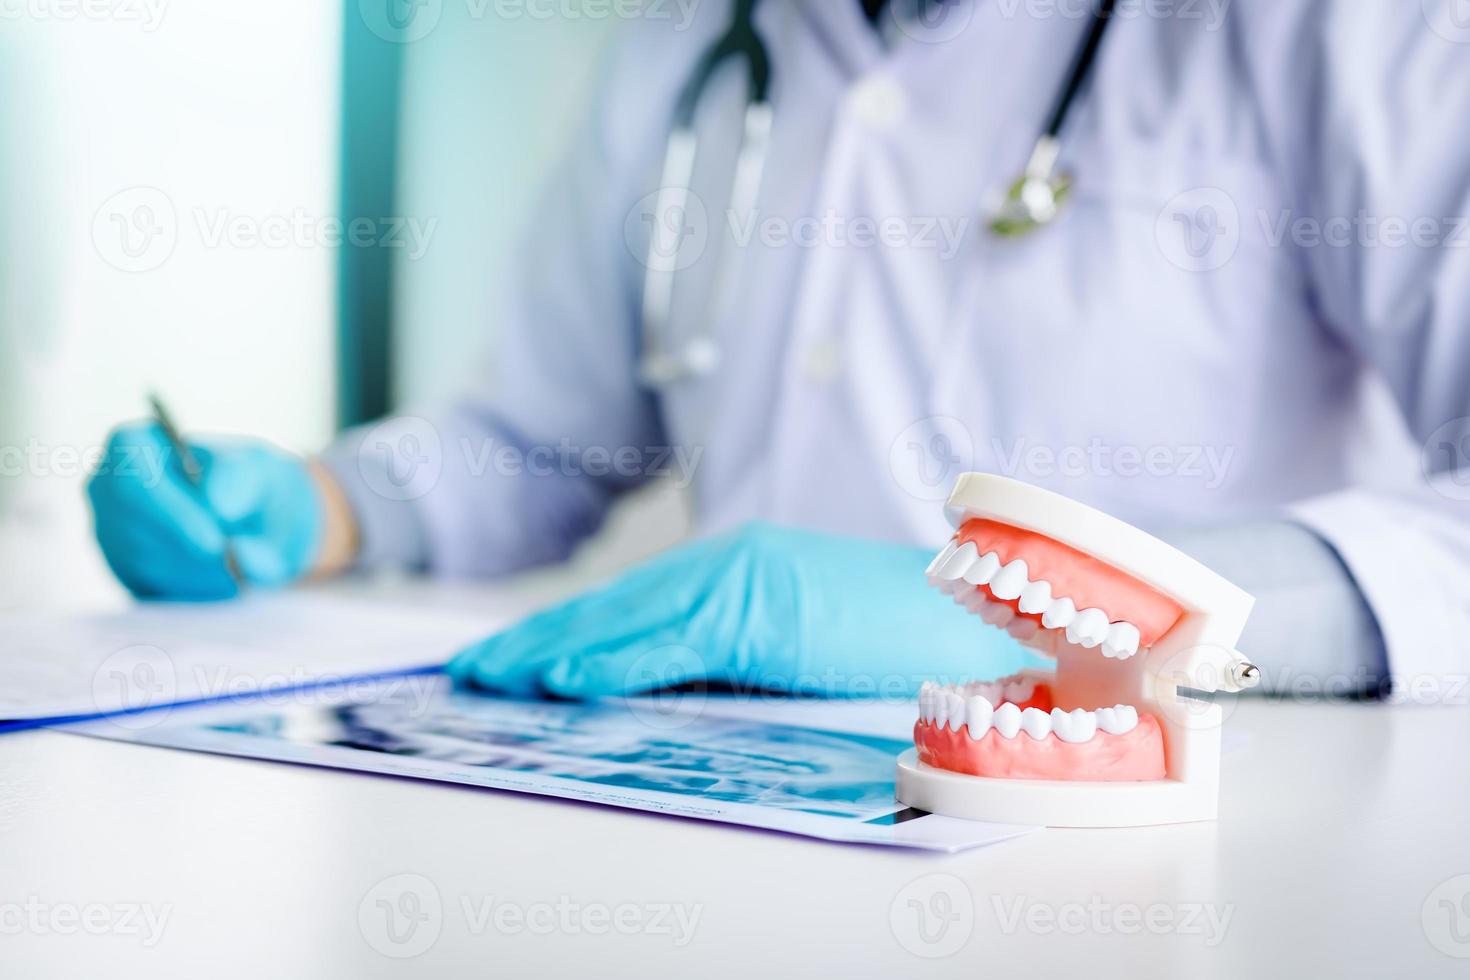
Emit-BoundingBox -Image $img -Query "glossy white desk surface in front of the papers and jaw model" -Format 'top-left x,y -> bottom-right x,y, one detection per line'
0,581 -> 1470,980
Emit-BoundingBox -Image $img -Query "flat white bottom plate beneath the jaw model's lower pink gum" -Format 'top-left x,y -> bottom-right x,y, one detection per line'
898,749 -> 1217,827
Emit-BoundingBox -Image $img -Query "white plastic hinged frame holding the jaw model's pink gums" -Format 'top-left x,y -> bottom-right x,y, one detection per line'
898,473 -> 1252,827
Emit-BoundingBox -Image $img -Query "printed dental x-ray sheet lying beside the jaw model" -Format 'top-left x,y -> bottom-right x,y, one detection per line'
71,677 -> 1033,852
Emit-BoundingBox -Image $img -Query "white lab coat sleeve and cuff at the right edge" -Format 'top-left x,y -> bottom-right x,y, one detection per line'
1258,0 -> 1470,702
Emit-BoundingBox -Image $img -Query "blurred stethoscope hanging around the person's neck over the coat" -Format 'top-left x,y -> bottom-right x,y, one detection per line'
638,0 -> 1117,388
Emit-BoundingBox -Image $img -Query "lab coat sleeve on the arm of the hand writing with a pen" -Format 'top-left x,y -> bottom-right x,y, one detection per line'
323,28 -> 698,577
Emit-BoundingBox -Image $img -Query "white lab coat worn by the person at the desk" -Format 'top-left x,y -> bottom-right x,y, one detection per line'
329,0 -> 1470,696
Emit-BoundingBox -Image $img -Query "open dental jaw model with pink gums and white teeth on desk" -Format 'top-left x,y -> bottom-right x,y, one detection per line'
898,473 -> 1260,827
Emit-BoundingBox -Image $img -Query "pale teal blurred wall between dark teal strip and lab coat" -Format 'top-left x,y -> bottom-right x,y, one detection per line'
392,0 -> 614,404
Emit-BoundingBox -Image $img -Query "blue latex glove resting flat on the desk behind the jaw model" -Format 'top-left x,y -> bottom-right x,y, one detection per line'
447,525 -> 1039,698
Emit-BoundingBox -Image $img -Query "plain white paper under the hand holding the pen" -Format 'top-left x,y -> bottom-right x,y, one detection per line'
0,592 -> 506,720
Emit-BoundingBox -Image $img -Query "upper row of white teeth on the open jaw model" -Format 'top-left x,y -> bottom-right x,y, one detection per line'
929,538 -> 1139,660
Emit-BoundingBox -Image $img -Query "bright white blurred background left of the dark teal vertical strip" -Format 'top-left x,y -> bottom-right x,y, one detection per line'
0,0 -> 341,604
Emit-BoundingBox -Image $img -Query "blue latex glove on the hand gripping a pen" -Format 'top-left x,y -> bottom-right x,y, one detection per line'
87,422 -> 323,599
